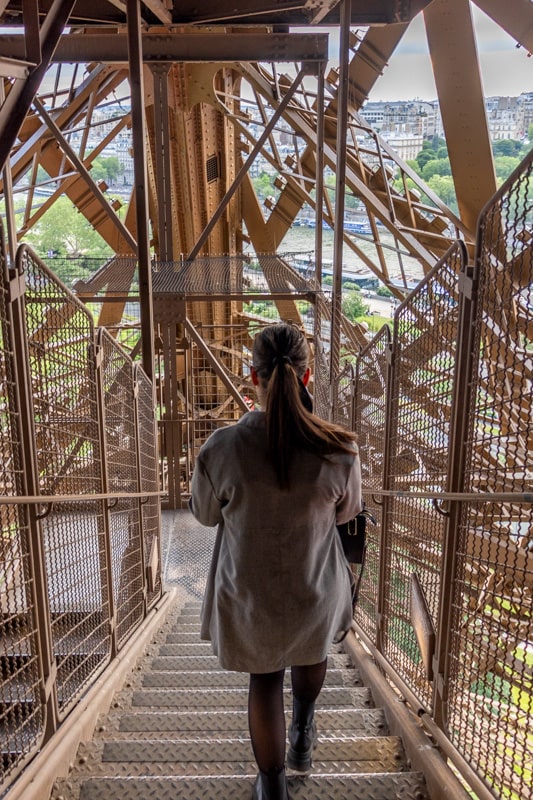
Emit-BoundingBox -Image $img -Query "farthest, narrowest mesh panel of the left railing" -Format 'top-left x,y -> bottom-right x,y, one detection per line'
134,364 -> 162,606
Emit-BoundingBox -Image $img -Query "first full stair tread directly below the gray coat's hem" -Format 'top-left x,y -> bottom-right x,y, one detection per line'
142,667 -> 361,689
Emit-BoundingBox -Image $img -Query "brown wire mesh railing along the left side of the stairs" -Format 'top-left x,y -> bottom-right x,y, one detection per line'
0,225 -> 162,788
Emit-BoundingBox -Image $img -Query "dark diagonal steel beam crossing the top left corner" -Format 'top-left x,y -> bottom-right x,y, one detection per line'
0,0 -> 75,168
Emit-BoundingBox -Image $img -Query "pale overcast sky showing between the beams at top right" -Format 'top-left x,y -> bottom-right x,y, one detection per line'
330,0 -> 533,100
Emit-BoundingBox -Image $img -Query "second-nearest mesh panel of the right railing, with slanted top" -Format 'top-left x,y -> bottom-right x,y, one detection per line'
382,244 -> 463,708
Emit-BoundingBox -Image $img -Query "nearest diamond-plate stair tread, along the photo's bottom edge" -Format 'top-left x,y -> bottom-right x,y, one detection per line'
72,772 -> 429,800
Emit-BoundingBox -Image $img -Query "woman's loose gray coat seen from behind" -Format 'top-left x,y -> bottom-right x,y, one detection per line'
191,411 -> 361,673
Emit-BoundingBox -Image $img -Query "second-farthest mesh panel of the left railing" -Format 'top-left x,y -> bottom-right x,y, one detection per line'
98,329 -> 144,646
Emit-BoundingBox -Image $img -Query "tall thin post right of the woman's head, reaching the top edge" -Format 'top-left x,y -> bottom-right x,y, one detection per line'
329,0 -> 352,419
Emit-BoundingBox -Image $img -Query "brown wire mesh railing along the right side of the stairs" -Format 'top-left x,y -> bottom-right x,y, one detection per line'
355,153 -> 533,800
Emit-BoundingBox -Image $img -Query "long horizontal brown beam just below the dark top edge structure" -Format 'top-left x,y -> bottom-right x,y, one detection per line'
2,31 -> 328,64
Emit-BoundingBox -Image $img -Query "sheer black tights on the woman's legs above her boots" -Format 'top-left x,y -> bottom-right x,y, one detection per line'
248,659 -> 328,772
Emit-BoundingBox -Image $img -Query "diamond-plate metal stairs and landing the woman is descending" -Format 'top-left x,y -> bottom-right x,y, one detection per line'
47,512 -> 428,800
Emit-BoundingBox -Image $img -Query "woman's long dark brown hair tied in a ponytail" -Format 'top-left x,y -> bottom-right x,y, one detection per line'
253,323 -> 356,489
